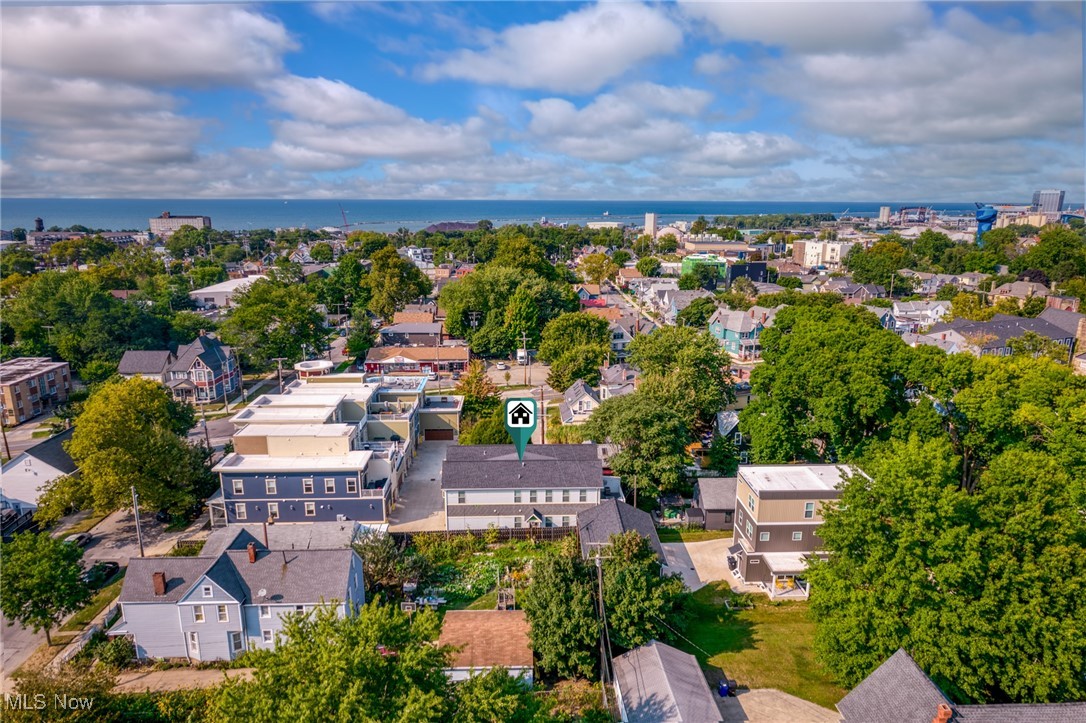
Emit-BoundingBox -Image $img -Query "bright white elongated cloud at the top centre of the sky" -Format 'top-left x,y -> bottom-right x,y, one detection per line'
421,3 -> 682,93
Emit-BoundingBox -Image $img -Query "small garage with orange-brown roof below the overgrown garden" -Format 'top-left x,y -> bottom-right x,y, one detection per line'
438,610 -> 535,686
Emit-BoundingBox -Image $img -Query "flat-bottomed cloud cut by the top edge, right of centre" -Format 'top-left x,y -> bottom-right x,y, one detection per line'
681,0 -> 931,53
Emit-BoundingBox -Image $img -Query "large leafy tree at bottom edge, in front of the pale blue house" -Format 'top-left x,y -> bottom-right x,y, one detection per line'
211,603 -> 450,723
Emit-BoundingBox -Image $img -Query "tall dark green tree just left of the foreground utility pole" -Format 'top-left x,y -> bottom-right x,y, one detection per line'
520,551 -> 599,677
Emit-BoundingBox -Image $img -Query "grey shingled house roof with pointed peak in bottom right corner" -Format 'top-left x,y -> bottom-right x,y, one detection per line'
837,648 -> 1086,723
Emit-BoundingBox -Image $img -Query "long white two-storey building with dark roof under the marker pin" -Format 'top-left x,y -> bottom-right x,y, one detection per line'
441,444 -> 605,530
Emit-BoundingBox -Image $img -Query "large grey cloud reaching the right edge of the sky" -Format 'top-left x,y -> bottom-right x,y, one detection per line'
763,9 -> 1083,145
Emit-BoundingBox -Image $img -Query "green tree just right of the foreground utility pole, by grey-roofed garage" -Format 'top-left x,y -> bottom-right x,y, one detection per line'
602,530 -> 689,648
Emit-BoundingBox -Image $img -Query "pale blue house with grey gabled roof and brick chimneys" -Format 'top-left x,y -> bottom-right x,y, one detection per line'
108,542 -> 366,662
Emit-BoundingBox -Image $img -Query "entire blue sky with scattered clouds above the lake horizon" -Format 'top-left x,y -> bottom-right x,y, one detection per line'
0,2 -> 1084,201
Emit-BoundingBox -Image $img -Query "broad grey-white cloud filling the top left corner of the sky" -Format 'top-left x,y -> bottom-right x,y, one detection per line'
2,4 -> 296,87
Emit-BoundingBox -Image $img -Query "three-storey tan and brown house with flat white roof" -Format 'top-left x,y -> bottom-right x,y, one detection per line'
728,465 -> 859,597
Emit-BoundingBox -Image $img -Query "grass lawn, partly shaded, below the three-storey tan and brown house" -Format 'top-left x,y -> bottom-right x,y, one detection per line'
682,582 -> 846,709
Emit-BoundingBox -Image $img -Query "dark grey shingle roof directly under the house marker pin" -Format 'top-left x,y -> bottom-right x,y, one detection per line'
441,444 -> 604,490
